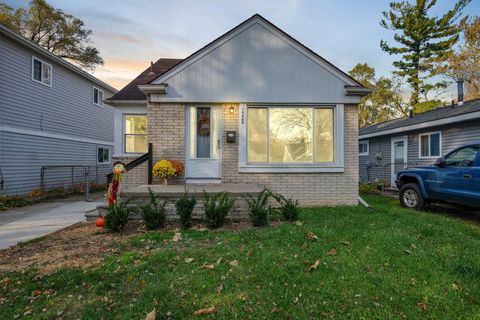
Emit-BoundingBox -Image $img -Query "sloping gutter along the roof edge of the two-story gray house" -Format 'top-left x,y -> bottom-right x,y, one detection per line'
0,24 -> 118,93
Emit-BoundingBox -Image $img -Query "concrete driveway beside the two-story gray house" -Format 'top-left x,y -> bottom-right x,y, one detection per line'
0,197 -> 103,249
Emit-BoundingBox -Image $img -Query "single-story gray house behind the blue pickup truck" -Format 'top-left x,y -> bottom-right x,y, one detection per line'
359,99 -> 480,186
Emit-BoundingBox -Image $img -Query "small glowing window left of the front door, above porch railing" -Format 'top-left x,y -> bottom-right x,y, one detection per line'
124,115 -> 148,153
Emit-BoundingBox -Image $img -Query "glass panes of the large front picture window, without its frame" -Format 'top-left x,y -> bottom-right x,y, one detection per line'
247,107 -> 334,164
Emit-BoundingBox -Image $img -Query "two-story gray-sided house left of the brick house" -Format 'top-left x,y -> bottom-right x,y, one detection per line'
0,25 -> 116,194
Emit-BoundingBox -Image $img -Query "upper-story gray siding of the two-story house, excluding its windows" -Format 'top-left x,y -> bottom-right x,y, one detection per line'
0,36 -> 114,141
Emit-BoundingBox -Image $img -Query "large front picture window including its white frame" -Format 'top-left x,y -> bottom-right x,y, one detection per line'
239,105 -> 343,172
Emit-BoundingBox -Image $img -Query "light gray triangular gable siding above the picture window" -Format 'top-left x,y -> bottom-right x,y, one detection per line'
152,23 -> 359,103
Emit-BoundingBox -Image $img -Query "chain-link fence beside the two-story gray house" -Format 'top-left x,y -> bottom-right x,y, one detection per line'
40,165 -> 112,201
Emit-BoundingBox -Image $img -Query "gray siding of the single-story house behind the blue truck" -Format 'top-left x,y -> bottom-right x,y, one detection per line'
359,120 -> 480,185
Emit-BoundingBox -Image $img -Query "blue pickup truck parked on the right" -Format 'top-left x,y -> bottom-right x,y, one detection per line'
395,142 -> 480,210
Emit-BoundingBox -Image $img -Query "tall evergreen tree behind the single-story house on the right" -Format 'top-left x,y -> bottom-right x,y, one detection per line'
380,0 -> 471,105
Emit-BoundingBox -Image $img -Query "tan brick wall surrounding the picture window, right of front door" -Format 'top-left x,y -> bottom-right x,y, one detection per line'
222,105 -> 358,206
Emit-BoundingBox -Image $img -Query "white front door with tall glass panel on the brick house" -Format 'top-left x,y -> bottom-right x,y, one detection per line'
185,105 -> 221,183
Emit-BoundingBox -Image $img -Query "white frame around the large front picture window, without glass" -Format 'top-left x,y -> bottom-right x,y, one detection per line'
238,104 -> 345,173
